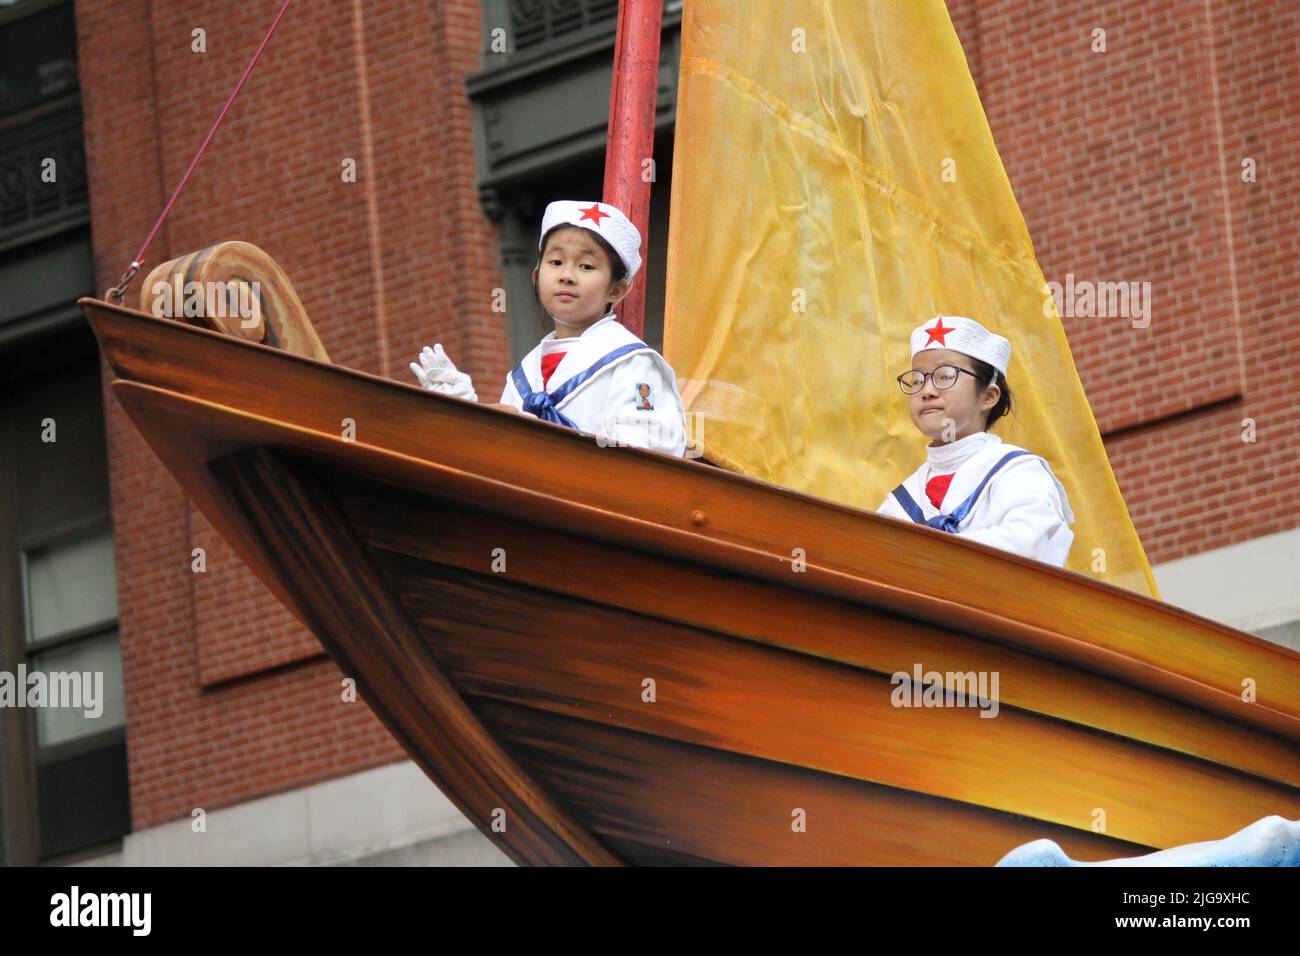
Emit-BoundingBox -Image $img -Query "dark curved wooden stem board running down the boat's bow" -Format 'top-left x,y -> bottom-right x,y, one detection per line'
211,449 -> 616,865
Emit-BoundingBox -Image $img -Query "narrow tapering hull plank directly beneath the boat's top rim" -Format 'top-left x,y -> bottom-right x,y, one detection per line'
343,471 -> 1300,787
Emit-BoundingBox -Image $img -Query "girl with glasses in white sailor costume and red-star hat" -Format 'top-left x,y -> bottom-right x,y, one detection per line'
878,316 -> 1074,567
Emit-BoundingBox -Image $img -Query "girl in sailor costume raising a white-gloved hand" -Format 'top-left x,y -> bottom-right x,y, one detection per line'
411,199 -> 686,455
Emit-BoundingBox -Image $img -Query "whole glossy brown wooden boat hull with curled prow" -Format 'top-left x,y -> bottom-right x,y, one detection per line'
79,243 -> 1300,865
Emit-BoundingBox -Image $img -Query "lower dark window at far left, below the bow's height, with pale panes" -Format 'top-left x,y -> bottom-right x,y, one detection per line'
0,361 -> 130,862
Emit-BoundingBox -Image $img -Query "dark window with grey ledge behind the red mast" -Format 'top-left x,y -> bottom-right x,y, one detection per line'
467,0 -> 681,362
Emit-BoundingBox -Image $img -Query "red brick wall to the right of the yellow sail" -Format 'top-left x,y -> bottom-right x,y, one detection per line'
949,0 -> 1300,562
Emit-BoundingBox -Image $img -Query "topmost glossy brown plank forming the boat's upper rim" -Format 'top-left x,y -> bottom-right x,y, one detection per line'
82,299 -> 1300,740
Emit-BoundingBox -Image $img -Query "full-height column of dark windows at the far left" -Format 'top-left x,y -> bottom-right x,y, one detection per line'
0,0 -> 130,864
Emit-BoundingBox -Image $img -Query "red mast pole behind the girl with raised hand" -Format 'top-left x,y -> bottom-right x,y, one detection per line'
605,0 -> 663,336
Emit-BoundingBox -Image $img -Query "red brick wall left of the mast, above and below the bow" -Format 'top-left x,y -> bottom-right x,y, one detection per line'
77,0 -> 507,829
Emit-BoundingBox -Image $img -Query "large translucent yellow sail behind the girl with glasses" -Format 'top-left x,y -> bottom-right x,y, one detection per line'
664,0 -> 1156,596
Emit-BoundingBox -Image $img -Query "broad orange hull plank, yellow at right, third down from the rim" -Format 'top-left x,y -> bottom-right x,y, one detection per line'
361,538 -> 1300,847
